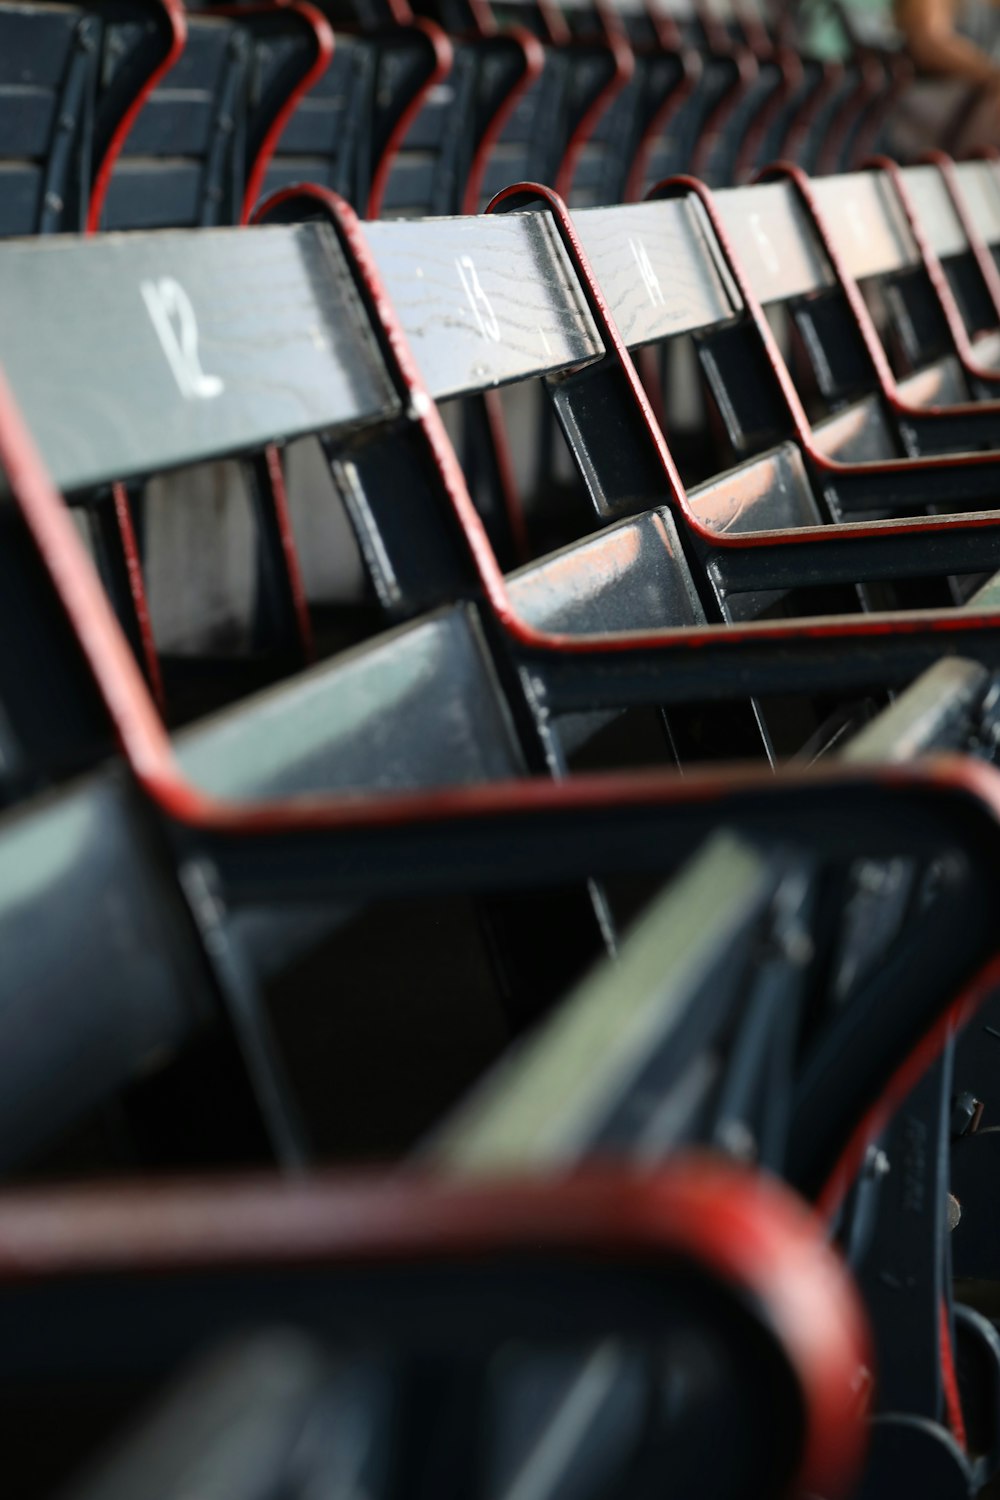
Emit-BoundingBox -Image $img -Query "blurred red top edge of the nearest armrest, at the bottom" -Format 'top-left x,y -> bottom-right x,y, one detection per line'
0,1152 -> 873,1497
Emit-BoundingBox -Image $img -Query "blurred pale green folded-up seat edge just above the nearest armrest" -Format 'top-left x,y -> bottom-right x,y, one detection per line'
429,831 -> 780,1176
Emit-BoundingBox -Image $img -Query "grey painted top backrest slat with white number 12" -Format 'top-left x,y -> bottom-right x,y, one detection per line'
0,225 -> 394,491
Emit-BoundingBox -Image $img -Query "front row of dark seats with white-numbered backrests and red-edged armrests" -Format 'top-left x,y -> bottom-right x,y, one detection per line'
0,146 -> 1000,1500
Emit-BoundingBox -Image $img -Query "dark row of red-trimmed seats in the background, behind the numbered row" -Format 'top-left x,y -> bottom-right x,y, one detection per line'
0,0 -> 929,236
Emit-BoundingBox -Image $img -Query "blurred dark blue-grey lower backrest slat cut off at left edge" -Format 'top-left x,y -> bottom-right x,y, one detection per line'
0,774 -> 213,1169
